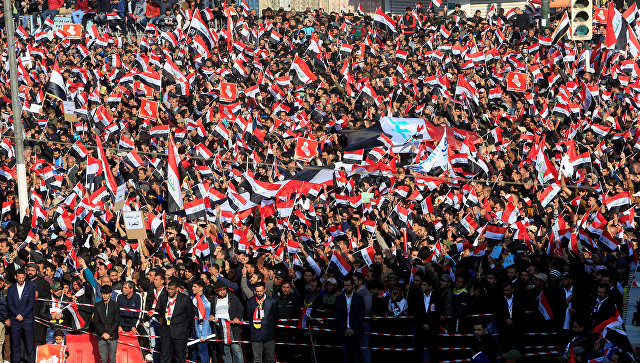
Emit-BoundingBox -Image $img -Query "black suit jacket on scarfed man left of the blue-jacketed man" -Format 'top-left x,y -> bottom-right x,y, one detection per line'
156,293 -> 196,339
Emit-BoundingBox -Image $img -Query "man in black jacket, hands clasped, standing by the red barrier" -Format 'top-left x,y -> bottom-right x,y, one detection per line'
93,285 -> 120,363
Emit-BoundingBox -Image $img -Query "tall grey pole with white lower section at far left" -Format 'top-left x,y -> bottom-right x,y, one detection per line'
4,0 -> 29,222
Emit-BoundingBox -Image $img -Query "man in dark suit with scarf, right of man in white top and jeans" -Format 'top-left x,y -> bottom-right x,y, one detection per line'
247,281 -> 278,363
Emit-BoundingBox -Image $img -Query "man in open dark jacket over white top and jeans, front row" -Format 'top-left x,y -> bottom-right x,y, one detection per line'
210,280 -> 244,363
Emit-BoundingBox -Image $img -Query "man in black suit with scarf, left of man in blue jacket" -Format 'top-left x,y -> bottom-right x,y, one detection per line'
156,278 -> 195,363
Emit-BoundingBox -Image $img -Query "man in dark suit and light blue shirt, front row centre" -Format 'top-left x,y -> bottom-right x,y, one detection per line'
336,276 -> 364,363
